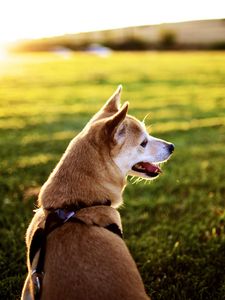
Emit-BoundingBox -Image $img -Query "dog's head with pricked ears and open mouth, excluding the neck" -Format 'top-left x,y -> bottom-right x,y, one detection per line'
86,86 -> 174,179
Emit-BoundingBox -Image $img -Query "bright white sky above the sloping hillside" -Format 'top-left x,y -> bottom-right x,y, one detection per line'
0,0 -> 225,43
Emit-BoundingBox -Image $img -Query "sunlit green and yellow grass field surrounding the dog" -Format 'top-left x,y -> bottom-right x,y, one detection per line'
0,52 -> 225,300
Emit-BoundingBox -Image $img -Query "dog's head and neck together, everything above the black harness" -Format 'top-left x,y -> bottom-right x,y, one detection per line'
39,86 -> 174,208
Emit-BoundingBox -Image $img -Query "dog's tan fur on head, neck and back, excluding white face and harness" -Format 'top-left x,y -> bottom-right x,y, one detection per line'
21,88 -> 153,300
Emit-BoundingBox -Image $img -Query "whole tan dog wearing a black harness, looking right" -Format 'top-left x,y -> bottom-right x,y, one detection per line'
21,86 -> 174,300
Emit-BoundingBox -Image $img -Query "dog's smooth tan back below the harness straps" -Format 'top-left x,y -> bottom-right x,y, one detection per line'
41,223 -> 149,300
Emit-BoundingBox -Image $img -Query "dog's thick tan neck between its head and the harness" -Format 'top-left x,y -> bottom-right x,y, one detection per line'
39,136 -> 126,208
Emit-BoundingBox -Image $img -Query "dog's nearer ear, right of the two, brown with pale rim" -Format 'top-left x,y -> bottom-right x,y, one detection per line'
105,102 -> 129,144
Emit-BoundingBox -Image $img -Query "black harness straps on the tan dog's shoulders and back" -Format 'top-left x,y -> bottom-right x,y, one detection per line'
29,201 -> 123,300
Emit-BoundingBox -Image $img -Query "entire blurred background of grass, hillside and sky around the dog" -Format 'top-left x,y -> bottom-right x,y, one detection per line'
0,0 -> 225,300
